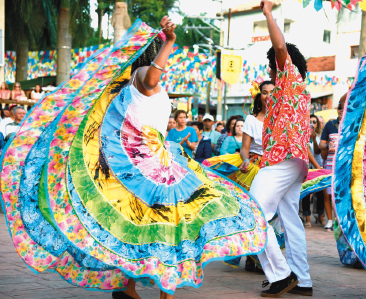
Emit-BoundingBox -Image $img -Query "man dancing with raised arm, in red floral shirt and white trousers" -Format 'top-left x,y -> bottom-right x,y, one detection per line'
250,0 -> 313,297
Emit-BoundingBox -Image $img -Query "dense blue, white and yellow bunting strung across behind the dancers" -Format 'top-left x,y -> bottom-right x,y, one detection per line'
5,44 -> 353,102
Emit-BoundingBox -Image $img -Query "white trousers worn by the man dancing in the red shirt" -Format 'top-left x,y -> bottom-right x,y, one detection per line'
250,158 -> 312,287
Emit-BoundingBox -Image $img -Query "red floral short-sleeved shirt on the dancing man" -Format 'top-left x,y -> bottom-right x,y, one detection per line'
260,55 -> 311,167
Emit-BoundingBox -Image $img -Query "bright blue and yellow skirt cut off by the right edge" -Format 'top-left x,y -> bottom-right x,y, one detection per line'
332,55 -> 366,268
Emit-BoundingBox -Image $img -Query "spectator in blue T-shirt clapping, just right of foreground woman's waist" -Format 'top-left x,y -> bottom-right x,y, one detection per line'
166,110 -> 198,157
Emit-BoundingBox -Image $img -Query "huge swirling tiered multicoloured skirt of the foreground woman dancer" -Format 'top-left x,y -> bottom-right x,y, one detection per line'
1,21 -> 267,294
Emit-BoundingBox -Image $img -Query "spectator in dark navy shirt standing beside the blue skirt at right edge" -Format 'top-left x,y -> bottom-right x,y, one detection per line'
319,103 -> 343,231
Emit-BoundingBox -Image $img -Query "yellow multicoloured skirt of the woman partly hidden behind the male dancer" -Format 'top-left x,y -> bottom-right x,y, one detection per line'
202,153 -> 332,269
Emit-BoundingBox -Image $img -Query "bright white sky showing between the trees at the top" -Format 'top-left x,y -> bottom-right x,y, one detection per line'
90,0 -> 248,38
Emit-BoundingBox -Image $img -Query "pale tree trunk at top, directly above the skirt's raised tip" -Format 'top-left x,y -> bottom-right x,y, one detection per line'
112,0 -> 131,44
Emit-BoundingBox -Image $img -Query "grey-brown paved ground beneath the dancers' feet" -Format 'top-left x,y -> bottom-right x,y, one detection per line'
0,213 -> 366,299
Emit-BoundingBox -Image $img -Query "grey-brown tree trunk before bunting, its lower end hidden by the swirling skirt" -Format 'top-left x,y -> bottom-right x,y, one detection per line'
56,0 -> 71,85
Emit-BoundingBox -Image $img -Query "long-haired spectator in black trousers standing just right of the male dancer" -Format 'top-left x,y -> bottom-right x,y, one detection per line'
302,115 -> 326,227
